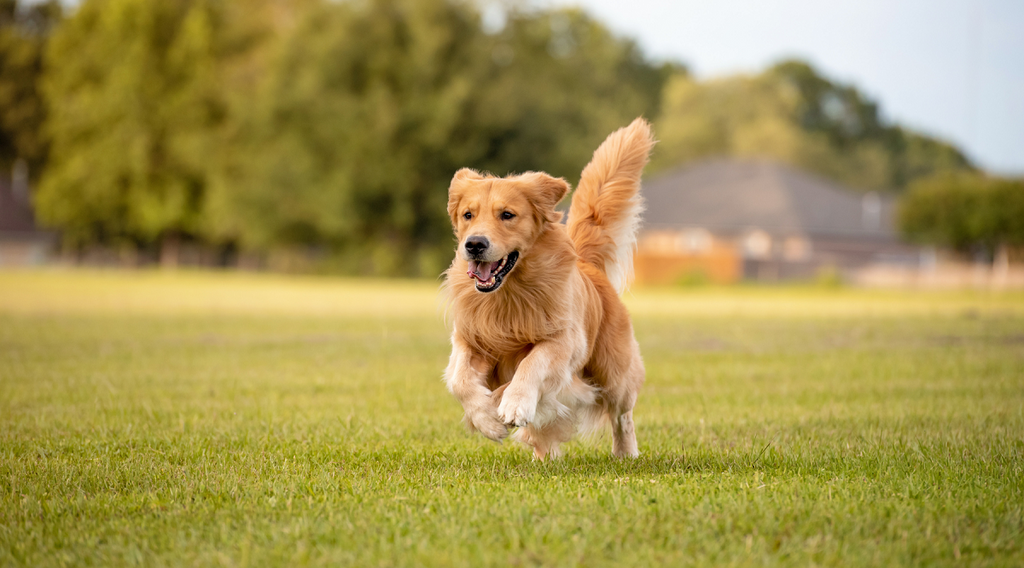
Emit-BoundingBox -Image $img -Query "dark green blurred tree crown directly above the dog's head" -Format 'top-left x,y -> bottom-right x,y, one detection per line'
468,9 -> 686,182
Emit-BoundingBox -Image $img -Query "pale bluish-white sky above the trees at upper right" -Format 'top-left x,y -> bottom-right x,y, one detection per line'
534,0 -> 1024,175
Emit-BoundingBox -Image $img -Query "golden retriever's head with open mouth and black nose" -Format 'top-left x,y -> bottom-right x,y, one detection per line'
447,168 -> 569,293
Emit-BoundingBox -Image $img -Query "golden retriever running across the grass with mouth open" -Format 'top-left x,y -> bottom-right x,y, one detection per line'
444,119 -> 654,460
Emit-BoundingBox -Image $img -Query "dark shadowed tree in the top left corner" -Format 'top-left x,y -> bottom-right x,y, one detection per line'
0,0 -> 61,180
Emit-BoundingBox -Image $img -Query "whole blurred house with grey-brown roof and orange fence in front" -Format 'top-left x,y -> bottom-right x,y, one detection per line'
636,159 -> 933,283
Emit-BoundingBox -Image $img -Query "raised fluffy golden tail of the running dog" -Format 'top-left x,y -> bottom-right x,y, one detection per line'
568,119 -> 654,293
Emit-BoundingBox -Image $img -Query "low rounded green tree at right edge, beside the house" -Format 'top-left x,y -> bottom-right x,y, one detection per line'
899,174 -> 1024,259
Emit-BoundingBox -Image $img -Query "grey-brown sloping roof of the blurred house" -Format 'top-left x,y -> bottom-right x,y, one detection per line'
643,159 -> 896,239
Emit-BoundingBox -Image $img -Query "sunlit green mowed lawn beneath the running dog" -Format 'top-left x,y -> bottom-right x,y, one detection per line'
0,271 -> 1024,566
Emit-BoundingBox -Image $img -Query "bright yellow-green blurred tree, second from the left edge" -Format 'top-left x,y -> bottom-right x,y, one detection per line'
37,0 -> 224,262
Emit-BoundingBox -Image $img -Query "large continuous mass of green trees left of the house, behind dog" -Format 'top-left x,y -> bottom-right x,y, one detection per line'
37,0 -> 666,273
